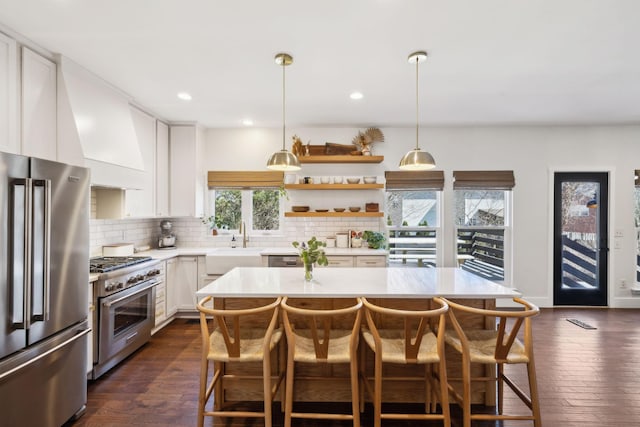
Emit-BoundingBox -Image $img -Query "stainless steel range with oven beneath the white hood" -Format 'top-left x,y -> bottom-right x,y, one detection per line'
89,256 -> 164,379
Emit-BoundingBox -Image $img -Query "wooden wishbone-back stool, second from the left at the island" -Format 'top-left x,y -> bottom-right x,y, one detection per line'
280,297 -> 362,427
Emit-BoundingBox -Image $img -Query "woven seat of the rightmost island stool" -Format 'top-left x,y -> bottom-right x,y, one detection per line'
445,330 -> 529,364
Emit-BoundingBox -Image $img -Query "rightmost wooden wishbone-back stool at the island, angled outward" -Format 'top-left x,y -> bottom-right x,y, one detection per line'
445,298 -> 542,427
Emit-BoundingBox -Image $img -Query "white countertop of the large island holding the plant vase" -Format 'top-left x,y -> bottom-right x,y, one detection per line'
196,267 -> 520,299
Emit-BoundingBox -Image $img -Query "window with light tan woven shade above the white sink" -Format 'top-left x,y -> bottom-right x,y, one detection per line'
208,171 -> 284,234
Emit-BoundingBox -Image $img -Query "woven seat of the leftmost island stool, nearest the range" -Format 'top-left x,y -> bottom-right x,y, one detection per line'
207,328 -> 283,362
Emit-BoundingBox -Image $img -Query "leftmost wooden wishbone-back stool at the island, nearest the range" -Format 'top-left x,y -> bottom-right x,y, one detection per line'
197,296 -> 284,427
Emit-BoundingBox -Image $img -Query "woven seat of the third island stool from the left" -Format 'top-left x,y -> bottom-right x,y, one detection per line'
362,329 -> 440,364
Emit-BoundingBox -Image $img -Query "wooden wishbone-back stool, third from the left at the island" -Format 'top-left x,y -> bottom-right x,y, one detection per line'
361,298 -> 451,427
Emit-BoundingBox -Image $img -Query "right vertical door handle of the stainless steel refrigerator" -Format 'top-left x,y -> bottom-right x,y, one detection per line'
31,179 -> 51,322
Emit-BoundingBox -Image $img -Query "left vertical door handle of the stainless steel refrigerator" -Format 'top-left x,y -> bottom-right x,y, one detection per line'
9,178 -> 33,329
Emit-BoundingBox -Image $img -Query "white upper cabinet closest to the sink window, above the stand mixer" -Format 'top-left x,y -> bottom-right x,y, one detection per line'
169,125 -> 205,217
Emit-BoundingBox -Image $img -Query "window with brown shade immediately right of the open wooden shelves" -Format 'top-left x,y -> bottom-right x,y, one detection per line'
385,171 -> 444,267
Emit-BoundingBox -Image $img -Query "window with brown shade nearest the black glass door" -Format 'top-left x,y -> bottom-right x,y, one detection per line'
453,171 -> 515,282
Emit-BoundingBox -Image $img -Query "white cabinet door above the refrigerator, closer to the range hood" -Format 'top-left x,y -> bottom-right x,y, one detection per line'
21,47 -> 58,160
